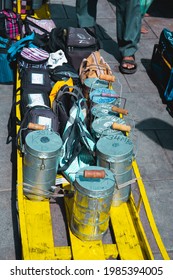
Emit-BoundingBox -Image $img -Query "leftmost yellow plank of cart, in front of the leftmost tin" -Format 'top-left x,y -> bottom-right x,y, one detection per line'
24,199 -> 55,260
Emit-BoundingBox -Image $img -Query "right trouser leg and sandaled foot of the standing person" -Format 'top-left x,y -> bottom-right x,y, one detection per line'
116,0 -> 141,73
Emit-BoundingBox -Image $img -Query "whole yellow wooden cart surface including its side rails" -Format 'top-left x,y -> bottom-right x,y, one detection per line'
13,1 -> 170,260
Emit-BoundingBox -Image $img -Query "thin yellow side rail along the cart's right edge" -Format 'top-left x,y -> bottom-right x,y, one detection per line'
132,161 -> 170,260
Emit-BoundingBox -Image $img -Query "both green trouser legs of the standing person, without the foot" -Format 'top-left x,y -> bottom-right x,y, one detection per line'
76,0 -> 141,57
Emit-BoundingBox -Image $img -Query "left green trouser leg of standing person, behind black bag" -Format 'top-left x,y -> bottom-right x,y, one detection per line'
76,0 -> 98,27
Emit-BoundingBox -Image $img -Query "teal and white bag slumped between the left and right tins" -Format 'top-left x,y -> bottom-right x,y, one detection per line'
58,98 -> 95,182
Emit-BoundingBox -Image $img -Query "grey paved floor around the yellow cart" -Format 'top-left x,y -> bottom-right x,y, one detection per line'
0,0 -> 173,260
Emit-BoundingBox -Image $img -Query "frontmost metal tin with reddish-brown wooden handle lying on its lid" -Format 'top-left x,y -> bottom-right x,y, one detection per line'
71,166 -> 115,240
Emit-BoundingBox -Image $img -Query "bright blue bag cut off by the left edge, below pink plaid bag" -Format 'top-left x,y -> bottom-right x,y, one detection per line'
0,37 -> 14,84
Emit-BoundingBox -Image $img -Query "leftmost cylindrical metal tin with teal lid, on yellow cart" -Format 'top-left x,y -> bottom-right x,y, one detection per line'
23,130 -> 62,200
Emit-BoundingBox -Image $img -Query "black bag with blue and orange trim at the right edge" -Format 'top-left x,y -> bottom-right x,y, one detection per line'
151,28 -> 173,101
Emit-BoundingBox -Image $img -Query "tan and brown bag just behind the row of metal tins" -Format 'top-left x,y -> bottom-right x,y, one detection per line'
79,51 -> 114,84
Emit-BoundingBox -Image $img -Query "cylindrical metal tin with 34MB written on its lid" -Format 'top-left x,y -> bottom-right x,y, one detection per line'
96,135 -> 134,206
